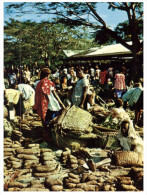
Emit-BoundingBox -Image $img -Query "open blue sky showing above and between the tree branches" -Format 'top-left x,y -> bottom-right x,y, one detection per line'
4,2 -> 127,29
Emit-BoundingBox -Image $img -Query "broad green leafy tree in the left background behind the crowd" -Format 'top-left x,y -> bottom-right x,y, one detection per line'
4,19 -> 95,70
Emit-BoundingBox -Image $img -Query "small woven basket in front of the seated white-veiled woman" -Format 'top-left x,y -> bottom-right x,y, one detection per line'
113,151 -> 143,166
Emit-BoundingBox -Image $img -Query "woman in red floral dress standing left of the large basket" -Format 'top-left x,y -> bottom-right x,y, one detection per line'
34,68 -> 65,142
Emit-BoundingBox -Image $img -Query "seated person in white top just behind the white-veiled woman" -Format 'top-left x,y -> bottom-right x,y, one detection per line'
111,98 -> 130,120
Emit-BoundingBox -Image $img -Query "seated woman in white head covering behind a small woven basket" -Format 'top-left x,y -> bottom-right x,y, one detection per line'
118,119 -> 143,154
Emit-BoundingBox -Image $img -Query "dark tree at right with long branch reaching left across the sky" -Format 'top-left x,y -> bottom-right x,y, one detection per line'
8,2 -> 143,78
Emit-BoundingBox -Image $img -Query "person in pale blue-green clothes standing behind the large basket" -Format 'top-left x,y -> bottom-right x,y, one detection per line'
72,69 -> 89,109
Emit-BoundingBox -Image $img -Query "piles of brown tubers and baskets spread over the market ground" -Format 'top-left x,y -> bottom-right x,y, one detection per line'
3,107 -> 143,192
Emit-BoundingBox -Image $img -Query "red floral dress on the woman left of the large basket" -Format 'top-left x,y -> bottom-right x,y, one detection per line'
34,79 -> 55,121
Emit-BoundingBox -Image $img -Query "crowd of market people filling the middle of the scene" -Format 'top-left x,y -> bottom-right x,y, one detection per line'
4,65 -> 143,153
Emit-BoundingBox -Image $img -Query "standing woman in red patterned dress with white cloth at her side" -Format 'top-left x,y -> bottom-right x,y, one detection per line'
34,68 -> 64,126
